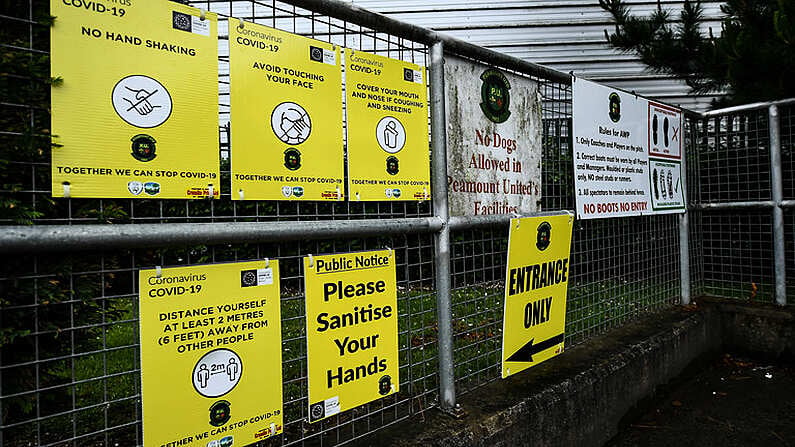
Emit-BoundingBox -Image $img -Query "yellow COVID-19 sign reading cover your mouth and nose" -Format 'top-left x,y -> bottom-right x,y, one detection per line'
345,49 -> 431,201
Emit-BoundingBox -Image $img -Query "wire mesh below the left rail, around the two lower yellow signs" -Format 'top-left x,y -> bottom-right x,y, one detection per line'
0,235 -> 438,446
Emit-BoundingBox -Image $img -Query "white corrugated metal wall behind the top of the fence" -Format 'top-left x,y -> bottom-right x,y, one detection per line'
353,0 -> 723,110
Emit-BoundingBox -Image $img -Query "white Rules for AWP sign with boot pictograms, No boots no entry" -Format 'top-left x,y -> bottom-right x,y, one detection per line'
572,78 -> 685,219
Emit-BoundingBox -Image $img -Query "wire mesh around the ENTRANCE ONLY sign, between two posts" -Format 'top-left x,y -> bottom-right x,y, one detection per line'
451,80 -> 680,392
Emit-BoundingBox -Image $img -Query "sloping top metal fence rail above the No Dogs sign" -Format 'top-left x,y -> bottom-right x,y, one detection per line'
290,0 -> 571,85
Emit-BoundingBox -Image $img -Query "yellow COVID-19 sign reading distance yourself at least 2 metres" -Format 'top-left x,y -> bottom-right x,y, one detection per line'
139,261 -> 284,447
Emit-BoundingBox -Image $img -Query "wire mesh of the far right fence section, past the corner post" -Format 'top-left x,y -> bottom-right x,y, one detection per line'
688,108 -> 792,301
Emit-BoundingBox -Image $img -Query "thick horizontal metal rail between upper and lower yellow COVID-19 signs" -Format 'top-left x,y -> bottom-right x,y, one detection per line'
0,217 -> 444,253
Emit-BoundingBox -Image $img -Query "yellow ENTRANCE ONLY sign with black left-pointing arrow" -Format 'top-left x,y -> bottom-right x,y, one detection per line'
502,213 -> 574,378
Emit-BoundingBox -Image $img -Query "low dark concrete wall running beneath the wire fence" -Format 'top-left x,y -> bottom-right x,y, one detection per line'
361,300 -> 795,447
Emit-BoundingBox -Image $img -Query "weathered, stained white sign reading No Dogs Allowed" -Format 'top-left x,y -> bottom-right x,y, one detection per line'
444,57 -> 541,216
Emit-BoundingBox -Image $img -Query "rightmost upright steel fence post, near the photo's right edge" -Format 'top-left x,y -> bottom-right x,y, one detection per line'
768,104 -> 787,306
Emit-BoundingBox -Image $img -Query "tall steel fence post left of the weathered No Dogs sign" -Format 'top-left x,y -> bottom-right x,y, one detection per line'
430,41 -> 456,411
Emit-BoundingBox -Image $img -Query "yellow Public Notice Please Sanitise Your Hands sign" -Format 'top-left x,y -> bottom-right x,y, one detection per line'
304,250 -> 400,422
